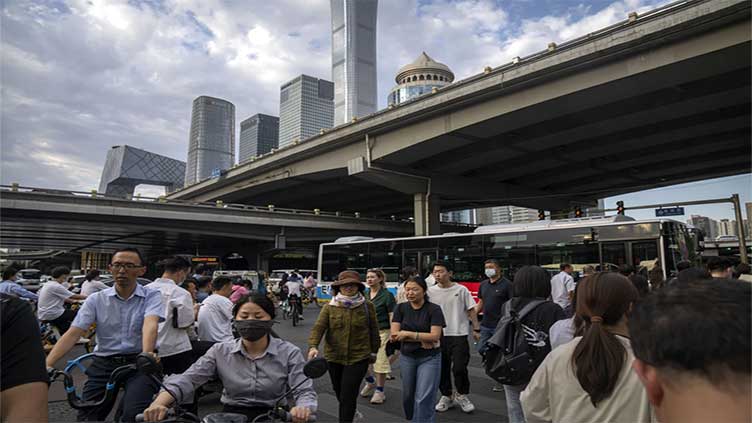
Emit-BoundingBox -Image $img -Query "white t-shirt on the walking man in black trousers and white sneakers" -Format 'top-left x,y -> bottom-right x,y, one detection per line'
428,283 -> 475,336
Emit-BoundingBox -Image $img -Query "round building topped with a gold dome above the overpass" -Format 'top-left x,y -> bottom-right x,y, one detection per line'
387,51 -> 454,104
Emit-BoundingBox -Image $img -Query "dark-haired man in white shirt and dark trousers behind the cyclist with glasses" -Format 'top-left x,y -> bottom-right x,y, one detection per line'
146,256 -> 194,375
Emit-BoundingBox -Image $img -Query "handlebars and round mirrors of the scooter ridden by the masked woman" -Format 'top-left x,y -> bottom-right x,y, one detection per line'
136,355 -> 329,423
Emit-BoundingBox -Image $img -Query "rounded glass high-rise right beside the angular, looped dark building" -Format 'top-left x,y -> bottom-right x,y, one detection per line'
185,95 -> 235,186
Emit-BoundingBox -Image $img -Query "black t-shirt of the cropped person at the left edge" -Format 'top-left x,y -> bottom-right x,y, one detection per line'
0,294 -> 49,391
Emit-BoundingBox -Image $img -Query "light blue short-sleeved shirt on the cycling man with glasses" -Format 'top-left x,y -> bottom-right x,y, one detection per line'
71,285 -> 165,356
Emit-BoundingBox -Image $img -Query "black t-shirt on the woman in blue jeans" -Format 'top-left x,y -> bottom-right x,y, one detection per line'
392,301 -> 446,357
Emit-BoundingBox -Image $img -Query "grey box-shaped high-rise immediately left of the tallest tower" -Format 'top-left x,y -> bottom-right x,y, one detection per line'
279,75 -> 334,148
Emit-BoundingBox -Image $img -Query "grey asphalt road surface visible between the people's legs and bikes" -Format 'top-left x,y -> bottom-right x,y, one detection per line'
49,304 -> 508,423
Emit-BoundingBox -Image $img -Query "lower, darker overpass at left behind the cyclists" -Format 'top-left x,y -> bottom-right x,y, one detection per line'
0,186 -> 471,264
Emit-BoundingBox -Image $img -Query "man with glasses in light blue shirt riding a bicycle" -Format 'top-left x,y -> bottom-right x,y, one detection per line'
47,248 -> 165,421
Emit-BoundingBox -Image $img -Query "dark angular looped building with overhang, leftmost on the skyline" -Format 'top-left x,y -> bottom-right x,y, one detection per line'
99,145 -> 185,197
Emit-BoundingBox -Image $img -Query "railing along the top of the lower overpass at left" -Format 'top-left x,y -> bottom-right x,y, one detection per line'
0,184 -> 475,228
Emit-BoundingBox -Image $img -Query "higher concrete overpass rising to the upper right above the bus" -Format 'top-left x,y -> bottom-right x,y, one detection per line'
169,0 -> 752,234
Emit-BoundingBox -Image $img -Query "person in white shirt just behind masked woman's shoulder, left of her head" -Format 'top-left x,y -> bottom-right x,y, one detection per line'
198,276 -> 235,342
